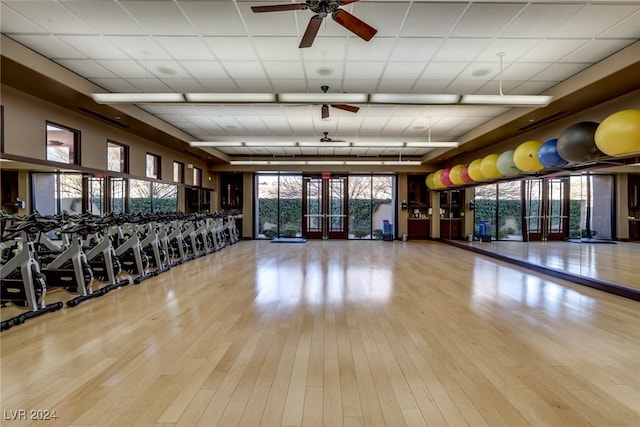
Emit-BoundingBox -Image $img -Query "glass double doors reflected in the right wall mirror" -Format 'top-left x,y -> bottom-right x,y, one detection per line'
523,177 -> 570,241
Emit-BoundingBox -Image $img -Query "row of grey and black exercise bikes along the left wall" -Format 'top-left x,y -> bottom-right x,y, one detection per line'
0,212 -> 241,331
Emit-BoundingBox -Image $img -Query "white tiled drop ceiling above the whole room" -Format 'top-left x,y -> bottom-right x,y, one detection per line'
0,0 -> 640,164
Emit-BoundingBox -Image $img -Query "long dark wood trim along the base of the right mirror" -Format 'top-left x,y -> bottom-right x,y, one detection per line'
439,239 -> 640,301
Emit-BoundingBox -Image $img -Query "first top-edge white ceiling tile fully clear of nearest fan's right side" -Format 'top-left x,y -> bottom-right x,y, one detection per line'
400,3 -> 466,37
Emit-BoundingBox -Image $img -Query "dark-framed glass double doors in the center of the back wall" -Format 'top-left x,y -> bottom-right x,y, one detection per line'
302,175 -> 349,239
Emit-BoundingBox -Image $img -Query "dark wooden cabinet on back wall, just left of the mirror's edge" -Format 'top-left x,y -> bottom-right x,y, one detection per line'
407,175 -> 431,239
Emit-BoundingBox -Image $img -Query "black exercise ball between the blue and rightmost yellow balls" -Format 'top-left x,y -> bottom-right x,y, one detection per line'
556,122 -> 602,163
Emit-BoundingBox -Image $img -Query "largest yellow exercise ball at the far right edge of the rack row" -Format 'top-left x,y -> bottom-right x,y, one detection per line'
595,110 -> 640,157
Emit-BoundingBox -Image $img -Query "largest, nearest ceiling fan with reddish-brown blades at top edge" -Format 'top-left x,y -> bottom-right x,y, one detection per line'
251,0 -> 378,48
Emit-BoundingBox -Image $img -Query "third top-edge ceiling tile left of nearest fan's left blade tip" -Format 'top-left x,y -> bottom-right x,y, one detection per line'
61,0 -> 144,35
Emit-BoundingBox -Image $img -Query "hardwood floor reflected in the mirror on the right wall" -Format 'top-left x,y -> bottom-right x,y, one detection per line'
456,241 -> 640,290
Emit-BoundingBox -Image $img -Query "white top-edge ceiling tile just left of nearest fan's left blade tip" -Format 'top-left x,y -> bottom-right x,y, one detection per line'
179,1 -> 247,36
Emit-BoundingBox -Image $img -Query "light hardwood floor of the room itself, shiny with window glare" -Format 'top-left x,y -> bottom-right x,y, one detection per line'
0,241 -> 640,427
